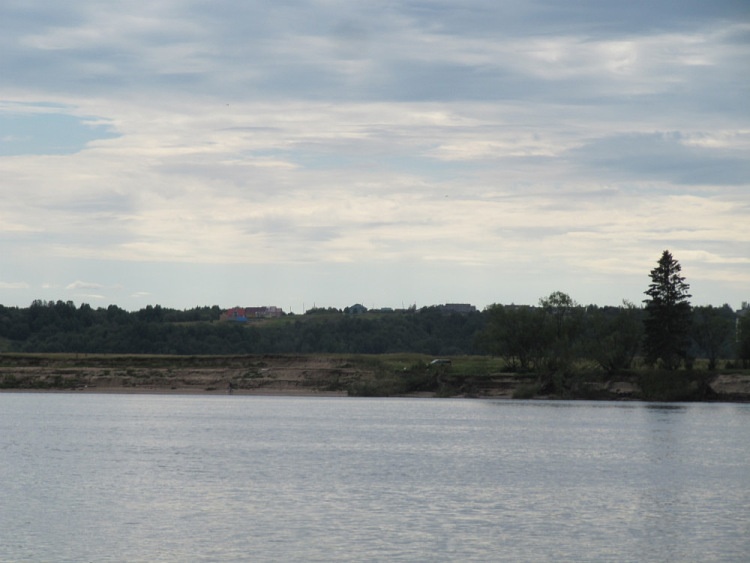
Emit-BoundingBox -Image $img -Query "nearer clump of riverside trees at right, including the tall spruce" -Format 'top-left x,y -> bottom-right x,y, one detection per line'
482,250 -> 750,373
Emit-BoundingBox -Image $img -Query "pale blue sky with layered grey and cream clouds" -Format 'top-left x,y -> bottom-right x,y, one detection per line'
0,0 -> 750,312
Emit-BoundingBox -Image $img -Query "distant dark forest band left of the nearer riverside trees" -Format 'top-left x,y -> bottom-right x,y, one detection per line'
0,301 -> 484,355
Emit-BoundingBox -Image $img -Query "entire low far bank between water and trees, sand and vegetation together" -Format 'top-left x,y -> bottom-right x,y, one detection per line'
0,354 -> 750,402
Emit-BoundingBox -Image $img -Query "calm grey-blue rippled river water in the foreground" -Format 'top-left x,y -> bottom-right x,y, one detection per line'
0,393 -> 750,562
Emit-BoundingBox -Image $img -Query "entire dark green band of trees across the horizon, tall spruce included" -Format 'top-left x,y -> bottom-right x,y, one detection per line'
0,251 -> 750,373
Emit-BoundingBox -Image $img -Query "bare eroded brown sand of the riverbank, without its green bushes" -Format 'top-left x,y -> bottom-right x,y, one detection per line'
0,354 -> 750,402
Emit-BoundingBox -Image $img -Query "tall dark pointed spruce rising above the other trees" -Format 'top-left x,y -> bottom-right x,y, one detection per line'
643,250 -> 692,370
